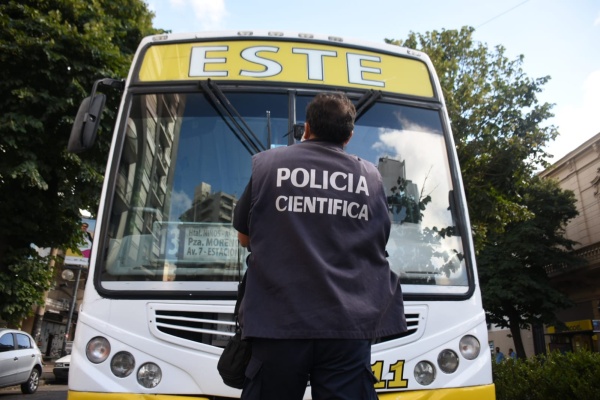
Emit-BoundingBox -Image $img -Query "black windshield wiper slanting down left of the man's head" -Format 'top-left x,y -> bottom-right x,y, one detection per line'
200,79 -> 266,155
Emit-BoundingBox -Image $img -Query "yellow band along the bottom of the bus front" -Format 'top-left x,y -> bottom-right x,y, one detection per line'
68,384 -> 496,400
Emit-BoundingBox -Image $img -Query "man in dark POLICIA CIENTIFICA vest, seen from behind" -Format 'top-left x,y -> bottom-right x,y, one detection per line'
234,93 -> 406,400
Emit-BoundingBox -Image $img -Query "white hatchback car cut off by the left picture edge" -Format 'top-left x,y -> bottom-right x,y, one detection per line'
0,328 -> 42,394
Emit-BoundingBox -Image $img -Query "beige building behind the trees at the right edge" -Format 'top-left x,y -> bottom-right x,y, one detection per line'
489,133 -> 600,356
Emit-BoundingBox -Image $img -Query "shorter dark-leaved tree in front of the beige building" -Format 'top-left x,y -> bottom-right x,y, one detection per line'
478,177 -> 580,358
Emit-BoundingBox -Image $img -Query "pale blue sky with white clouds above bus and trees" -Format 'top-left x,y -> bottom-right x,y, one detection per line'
146,0 -> 600,163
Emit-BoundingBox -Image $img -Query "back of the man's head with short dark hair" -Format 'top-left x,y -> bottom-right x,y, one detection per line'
306,92 -> 356,143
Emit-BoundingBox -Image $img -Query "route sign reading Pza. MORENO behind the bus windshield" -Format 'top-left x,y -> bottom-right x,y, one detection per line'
181,223 -> 238,263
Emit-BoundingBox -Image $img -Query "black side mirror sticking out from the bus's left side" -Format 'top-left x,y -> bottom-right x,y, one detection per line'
67,94 -> 106,153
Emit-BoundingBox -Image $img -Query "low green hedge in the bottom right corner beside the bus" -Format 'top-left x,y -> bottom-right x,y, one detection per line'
493,351 -> 600,400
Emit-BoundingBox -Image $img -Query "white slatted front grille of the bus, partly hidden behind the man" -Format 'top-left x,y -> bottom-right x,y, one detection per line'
148,303 -> 427,348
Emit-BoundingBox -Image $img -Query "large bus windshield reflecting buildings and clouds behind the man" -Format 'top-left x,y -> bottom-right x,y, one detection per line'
98,91 -> 471,295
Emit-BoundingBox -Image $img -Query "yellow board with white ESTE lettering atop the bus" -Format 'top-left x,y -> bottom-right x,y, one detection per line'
136,40 -> 434,98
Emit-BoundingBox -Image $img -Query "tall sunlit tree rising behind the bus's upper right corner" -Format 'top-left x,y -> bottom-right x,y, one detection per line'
386,27 -> 557,245
